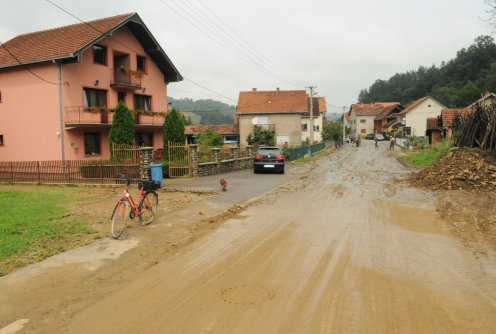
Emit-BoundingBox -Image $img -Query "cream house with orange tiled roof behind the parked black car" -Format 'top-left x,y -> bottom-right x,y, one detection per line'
236,88 -> 325,146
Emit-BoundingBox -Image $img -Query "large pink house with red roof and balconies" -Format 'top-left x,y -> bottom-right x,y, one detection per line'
0,13 -> 182,161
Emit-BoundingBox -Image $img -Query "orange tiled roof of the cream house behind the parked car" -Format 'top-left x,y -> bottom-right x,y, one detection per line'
236,90 -> 308,114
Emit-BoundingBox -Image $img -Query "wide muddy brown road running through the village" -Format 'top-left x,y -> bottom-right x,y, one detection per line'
0,141 -> 496,333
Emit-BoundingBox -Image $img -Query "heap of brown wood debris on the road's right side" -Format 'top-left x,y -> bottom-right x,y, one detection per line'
408,148 -> 496,191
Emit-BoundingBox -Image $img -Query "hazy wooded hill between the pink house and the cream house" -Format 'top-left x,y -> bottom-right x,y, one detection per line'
168,97 -> 236,125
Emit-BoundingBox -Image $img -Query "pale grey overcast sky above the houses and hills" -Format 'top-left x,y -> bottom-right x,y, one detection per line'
0,0 -> 493,112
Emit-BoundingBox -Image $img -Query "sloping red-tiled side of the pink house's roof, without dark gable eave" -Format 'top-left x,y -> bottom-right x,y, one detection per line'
0,13 -> 135,67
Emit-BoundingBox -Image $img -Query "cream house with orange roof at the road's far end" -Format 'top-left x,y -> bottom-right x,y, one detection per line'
348,102 -> 403,137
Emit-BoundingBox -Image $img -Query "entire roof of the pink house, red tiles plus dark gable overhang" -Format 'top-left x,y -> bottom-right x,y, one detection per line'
0,13 -> 182,82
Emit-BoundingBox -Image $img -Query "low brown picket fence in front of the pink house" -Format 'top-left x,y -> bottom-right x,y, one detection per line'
0,160 -> 140,184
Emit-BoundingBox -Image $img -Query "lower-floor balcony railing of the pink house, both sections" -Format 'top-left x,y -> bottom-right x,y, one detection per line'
64,106 -> 164,126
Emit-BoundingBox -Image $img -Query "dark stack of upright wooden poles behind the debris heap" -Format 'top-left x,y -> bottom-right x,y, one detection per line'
453,104 -> 496,153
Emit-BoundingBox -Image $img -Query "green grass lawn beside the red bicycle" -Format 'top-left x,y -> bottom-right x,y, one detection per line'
0,187 -> 95,276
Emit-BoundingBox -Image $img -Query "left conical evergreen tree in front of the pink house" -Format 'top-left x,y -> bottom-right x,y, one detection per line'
109,102 -> 134,157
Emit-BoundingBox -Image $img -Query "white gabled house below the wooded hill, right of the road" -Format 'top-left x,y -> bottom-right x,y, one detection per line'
397,96 -> 446,137
